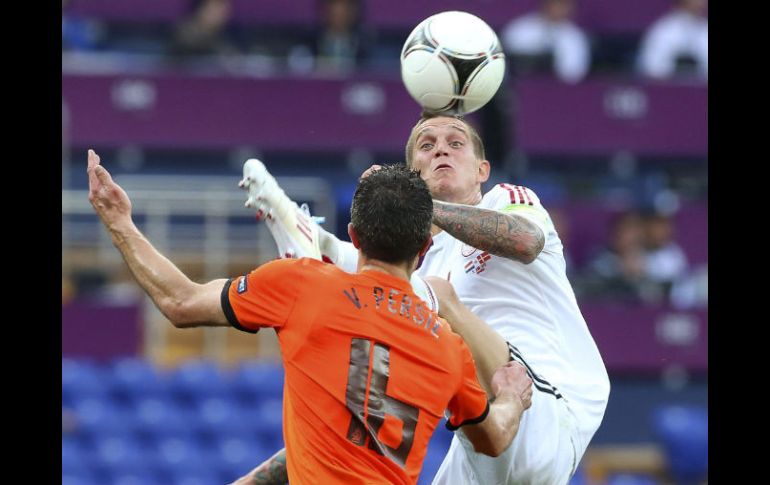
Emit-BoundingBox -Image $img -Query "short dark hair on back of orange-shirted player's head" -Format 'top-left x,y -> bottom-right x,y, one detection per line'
350,164 -> 433,263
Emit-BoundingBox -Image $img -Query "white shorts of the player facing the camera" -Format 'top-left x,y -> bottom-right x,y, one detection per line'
432,342 -> 585,485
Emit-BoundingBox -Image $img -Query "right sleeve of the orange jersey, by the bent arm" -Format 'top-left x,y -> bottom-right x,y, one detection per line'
446,334 -> 489,431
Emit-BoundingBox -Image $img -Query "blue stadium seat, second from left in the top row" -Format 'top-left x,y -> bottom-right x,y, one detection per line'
110,357 -> 168,400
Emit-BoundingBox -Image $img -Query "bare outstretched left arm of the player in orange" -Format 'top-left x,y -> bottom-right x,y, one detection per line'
87,150 -> 229,327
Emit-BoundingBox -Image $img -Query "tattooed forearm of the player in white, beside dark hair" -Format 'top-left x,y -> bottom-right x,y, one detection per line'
433,200 -> 545,263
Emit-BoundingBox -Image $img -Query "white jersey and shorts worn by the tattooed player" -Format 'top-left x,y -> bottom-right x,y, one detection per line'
417,184 -> 609,485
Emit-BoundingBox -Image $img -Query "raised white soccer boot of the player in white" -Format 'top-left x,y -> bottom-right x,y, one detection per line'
238,158 -> 322,260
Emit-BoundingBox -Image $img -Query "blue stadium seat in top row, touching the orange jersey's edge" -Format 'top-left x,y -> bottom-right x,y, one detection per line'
230,360 -> 284,403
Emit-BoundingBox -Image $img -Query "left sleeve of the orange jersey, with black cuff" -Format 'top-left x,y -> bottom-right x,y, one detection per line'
222,259 -> 304,333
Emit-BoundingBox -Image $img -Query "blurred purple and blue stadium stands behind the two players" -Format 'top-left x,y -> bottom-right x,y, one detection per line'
62,0 -> 708,485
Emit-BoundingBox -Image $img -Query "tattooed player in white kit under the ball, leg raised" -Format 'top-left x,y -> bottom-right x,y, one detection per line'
231,116 -> 610,485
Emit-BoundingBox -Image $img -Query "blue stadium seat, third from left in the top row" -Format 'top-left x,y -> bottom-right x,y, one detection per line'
169,361 -> 229,402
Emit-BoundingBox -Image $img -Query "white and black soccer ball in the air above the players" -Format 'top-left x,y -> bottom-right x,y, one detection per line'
401,11 -> 505,115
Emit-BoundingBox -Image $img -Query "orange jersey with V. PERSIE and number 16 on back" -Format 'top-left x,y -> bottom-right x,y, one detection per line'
222,258 -> 489,485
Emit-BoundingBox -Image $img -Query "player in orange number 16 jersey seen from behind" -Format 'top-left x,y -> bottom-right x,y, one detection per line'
88,151 -> 532,485
